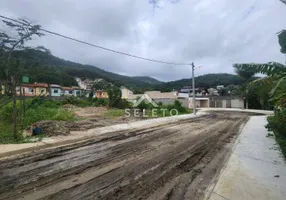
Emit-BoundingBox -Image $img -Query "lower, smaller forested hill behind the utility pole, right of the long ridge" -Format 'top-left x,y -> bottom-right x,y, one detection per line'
156,73 -> 248,91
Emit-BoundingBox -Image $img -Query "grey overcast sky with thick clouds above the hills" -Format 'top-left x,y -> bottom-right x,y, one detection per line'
0,0 -> 286,81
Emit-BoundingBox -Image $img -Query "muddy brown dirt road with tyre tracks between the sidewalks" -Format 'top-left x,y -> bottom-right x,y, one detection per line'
0,112 -> 248,200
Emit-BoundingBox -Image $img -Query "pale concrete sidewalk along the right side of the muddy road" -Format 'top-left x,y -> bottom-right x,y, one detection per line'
208,116 -> 286,200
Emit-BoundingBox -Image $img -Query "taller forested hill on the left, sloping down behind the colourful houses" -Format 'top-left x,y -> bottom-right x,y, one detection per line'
9,49 -> 156,89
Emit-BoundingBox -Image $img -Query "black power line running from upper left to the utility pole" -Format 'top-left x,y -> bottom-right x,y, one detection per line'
0,15 -> 191,65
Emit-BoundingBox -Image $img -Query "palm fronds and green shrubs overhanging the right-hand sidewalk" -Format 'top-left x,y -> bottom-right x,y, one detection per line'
234,6 -> 286,158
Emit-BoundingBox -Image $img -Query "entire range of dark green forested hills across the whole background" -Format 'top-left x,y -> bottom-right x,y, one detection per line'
5,49 -> 249,93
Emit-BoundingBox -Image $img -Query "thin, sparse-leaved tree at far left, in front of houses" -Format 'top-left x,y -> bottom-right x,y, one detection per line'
0,19 -> 44,138
